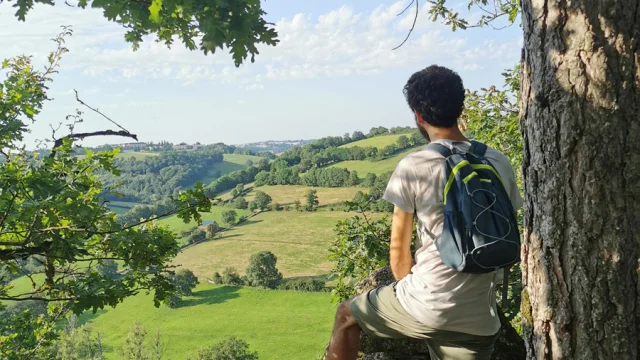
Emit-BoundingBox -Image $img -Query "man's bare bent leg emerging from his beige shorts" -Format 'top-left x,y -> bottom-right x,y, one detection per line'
327,301 -> 360,360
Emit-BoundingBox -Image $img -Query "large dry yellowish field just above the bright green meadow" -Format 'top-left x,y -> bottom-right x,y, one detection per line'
174,211 -> 352,278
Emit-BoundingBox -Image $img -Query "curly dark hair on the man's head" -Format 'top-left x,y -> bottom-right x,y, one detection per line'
403,65 -> 465,128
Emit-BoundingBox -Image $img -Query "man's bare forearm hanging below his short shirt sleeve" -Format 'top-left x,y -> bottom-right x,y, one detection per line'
389,206 -> 413,280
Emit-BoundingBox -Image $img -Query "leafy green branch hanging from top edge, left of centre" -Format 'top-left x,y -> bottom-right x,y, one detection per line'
0,0 -> 278,66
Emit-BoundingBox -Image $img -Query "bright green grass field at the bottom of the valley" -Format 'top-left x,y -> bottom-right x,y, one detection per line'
81,279 -> 335,360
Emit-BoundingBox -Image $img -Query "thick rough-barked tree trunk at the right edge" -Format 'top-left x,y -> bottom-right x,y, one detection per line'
520,0 -> 640,360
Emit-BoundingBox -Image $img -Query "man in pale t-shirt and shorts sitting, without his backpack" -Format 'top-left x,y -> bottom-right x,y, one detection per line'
327,65 -> 522,360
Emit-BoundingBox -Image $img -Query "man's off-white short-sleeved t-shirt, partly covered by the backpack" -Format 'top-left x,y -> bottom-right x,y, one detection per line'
383,139 -> 522,336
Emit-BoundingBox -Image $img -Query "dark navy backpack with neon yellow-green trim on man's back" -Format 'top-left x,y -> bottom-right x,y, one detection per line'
426,141 -> 520,306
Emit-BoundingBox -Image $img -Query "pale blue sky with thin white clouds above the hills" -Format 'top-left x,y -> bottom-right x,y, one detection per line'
0,0 -> 522,145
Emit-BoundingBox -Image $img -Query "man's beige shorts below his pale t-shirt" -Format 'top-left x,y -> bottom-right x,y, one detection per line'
351,283 -> 497,360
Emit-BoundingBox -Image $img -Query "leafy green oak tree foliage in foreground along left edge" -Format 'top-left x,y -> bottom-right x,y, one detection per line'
0,30 -> 211,359
